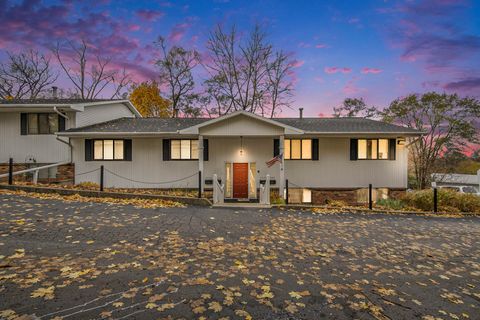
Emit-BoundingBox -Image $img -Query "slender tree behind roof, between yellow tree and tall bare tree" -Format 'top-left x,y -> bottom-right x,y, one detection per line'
155,37 -> 200,117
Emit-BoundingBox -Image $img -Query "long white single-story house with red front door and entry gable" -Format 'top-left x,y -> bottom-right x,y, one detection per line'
57,111 -> 420,203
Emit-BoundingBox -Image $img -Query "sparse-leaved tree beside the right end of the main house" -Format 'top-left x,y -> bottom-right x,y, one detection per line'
382,92 -> 480,188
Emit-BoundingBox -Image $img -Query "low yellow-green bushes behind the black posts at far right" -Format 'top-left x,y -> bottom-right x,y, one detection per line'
402,189 -> 480,213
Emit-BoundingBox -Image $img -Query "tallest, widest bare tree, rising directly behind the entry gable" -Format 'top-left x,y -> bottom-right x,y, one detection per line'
204,25 -> 293,117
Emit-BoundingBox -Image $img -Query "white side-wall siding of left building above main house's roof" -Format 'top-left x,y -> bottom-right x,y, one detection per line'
76,103 -> 135,127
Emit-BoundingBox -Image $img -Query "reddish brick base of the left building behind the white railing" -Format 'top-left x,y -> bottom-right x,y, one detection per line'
0,163 -> 75,183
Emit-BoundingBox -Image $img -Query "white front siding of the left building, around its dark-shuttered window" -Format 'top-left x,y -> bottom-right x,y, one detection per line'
0,112 -> 71,163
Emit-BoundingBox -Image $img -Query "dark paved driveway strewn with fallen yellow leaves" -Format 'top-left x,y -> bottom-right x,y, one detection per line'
0,194 -> 480,320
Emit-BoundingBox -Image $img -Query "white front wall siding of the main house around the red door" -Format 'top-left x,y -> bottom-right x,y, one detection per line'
72,137 -> 407,188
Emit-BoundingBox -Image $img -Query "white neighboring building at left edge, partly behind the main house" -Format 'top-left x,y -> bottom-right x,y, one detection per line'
0,99 -> 141,180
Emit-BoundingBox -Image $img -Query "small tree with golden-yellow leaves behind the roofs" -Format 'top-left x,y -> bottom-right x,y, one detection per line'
129,81 -> 172,118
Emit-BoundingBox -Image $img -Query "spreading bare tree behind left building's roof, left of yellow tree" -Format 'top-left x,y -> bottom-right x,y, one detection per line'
52,40 -> 132,100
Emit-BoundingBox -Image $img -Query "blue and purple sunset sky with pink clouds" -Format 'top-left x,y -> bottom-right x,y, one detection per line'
0,0 -> 480,117
